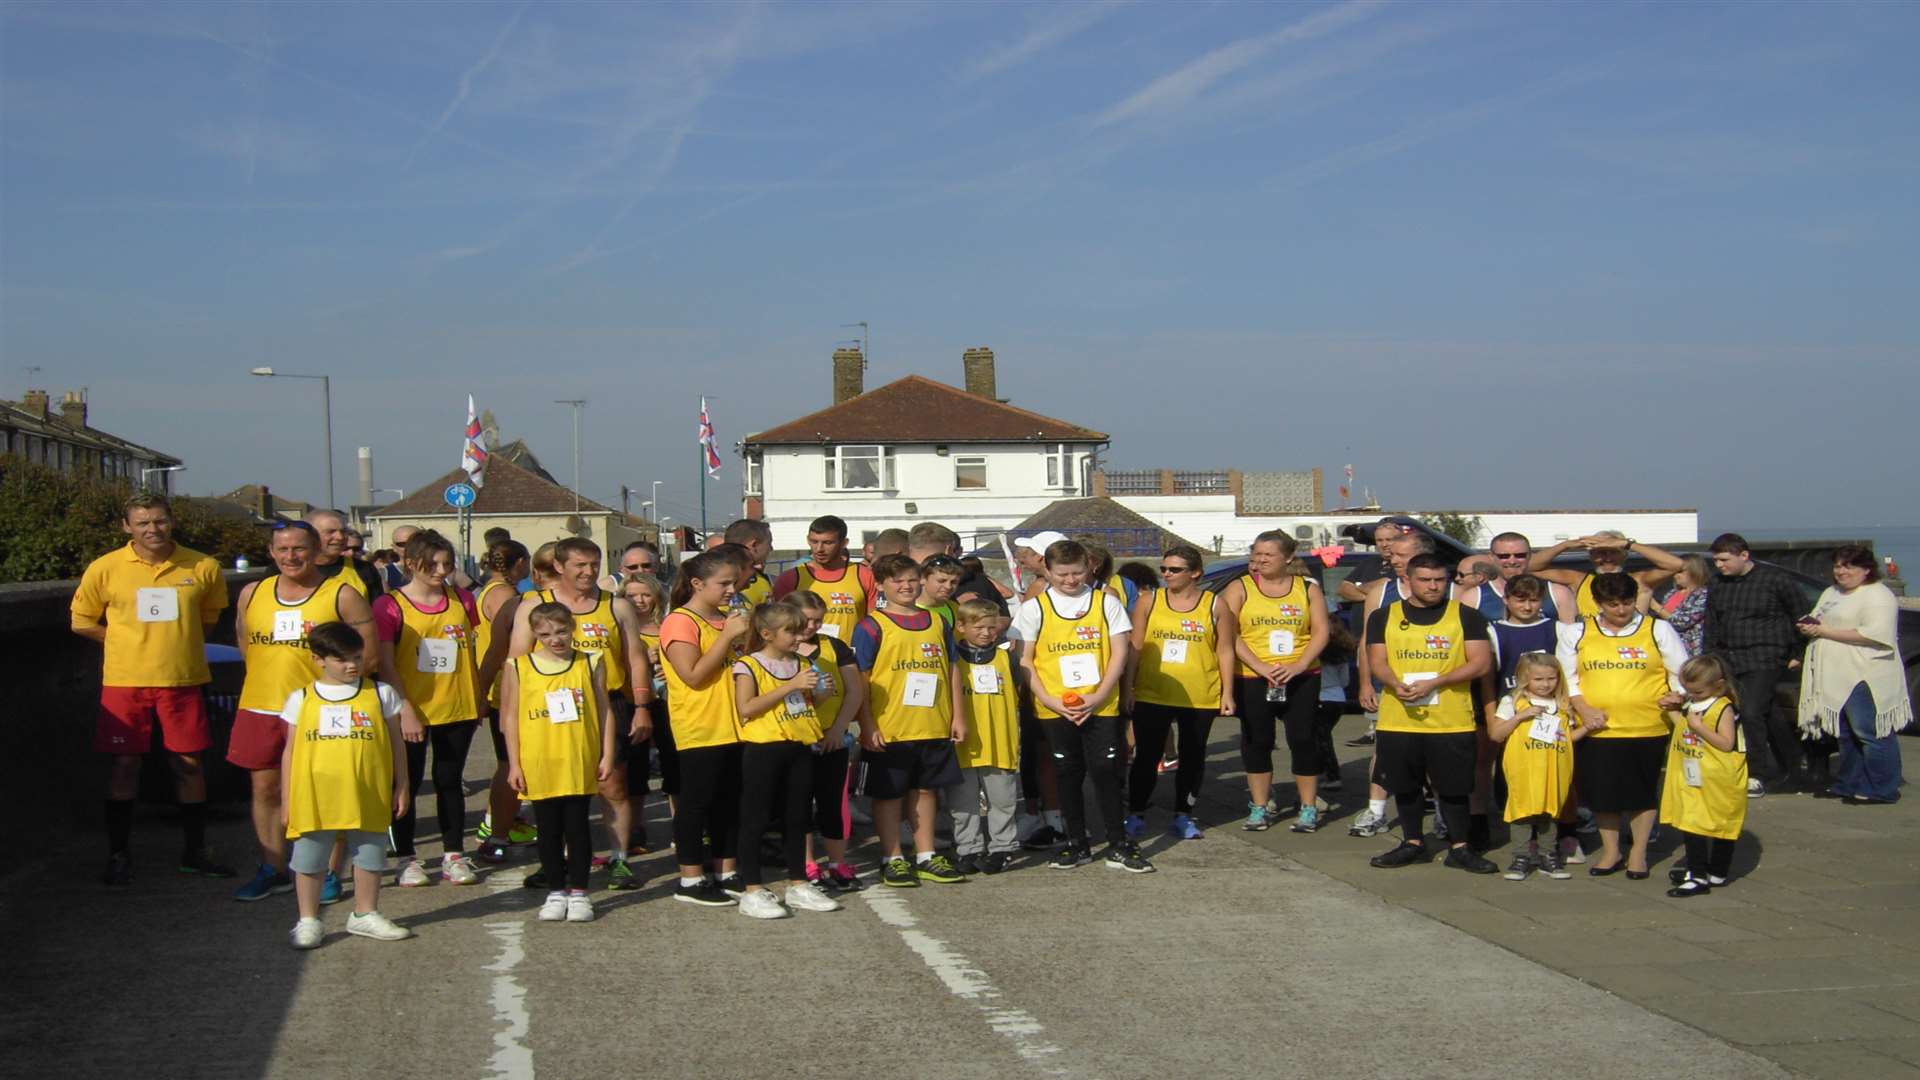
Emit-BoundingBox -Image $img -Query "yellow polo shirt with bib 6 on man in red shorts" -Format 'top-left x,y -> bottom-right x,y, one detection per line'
71,542 -> 227,686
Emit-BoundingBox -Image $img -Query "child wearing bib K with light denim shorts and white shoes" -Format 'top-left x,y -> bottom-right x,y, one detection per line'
280,623 -> 417,949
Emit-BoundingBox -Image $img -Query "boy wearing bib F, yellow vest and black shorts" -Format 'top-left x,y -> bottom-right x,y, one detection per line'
852,555 -> 966,888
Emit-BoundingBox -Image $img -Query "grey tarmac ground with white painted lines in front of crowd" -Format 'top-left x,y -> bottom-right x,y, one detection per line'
0,719 -> 1920,1080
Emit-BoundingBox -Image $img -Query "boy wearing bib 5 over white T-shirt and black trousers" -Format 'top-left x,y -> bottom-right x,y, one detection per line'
1012,540 -> 1154,874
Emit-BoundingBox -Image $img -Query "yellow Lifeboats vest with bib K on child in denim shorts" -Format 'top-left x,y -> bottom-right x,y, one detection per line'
280,678 -> 394,840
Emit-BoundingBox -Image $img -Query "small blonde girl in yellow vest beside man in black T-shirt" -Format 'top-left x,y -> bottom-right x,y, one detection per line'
1486,651 -> 1586,882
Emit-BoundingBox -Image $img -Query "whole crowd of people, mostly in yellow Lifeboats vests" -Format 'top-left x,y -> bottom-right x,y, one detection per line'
73,494 -> 1910,949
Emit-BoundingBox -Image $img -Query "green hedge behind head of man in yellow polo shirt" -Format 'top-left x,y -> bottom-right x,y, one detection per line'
0,454 -> 267,582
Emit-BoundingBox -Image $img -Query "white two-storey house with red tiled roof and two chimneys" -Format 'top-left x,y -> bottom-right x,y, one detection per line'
741,348 -> 1108,550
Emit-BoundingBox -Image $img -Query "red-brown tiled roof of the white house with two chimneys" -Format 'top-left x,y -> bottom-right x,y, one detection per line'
743,375 -> 1106,446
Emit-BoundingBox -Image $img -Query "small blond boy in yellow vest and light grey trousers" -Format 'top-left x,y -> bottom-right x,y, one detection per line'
947,600 -> 1020,874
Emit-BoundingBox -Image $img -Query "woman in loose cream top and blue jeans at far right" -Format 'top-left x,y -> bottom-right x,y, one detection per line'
1799,546 -> 1912,805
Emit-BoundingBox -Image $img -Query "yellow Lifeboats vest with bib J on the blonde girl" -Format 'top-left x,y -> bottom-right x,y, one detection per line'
513,650 -> 605,801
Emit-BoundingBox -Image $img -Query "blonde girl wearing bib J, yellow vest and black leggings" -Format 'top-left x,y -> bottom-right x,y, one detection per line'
499,600 -> 618,922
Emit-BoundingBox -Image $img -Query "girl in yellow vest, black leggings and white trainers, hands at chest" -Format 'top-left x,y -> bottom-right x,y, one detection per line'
733,601 -> 839,919
